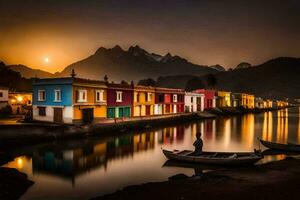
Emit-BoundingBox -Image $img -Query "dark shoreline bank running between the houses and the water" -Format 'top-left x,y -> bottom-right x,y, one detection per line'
0,108 -> 292,149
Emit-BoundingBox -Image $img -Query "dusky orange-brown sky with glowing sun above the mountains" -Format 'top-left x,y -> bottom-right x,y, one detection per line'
0,0 -> 300,72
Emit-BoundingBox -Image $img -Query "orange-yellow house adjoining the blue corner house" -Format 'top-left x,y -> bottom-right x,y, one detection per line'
73,78 -> 107,122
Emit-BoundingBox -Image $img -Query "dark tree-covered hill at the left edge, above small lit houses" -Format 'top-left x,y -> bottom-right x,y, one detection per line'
0,61 -> 32,91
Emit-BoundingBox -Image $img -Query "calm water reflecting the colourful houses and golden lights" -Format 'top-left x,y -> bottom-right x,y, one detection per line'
5,108 -> 300,200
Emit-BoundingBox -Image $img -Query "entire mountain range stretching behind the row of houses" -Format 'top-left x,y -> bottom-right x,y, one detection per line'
0,45 -> 300,99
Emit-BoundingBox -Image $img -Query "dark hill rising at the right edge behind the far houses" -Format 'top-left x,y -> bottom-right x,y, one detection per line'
215,57 -> 300,99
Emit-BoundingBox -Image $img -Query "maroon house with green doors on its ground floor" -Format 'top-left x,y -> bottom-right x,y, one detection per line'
107,83 -> 134,119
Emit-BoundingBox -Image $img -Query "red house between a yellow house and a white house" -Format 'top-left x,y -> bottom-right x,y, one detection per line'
154,88 -> 184,115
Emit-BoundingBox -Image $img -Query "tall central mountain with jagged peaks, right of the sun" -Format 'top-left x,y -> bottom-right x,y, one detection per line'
58,45 -> 217,81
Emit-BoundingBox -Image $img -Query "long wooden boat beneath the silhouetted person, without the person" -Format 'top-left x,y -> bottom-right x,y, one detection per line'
162,149 -> 263,165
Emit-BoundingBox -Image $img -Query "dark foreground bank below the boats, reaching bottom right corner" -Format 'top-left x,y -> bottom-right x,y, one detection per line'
95,158 -> 300,200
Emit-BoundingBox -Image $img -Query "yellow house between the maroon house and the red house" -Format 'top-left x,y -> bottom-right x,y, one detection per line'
133,85 -> 155,117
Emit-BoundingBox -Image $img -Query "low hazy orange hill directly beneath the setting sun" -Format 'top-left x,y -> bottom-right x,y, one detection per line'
8,65 -> 55,78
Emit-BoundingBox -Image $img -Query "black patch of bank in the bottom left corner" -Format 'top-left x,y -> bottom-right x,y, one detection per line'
0,167 -> 33,200
